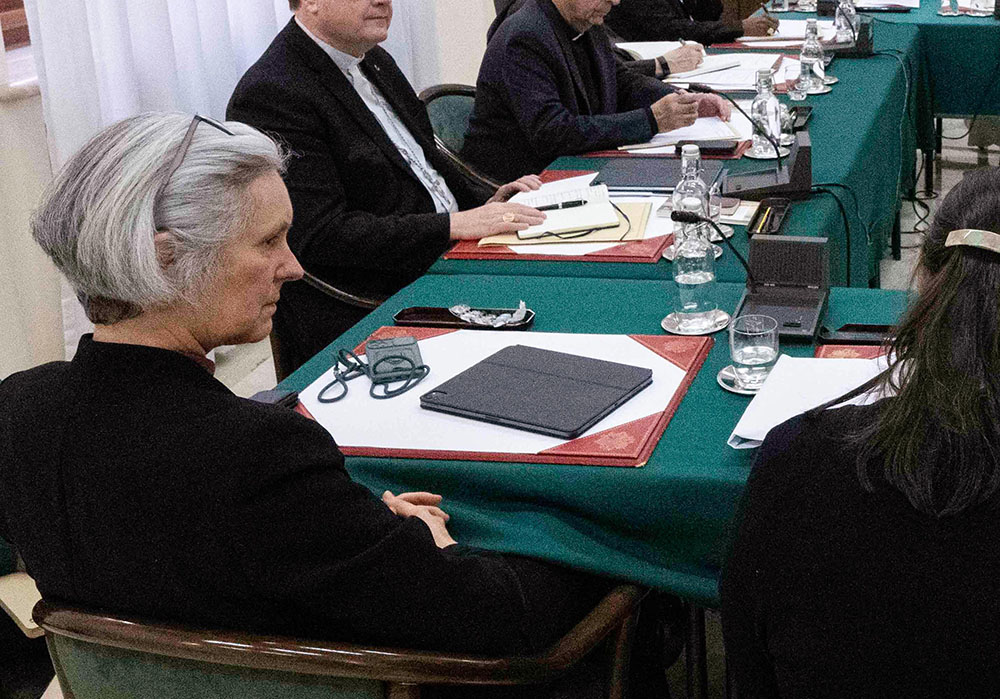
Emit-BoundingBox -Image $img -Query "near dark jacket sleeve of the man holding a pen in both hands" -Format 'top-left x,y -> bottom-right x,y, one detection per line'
503,35 -> 653,160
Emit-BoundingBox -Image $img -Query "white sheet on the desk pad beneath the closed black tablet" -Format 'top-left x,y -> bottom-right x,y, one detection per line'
299,330 -> 685,454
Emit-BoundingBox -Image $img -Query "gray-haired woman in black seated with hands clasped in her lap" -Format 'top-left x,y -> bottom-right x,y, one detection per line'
0,114 -> 607,668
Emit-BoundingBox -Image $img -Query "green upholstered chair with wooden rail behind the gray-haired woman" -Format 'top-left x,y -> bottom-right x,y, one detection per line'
34,585 -> 643,699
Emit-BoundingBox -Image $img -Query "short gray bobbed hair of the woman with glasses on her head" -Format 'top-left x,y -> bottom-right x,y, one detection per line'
31,112 -> 286,324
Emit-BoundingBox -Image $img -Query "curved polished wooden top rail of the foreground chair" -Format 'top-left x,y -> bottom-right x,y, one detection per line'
33,585 -> 645,684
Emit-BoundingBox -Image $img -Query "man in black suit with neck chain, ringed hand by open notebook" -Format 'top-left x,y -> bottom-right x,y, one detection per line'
226,0 -> 543,373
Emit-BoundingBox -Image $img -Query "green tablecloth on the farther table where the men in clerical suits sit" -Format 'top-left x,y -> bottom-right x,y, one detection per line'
430,25 -> 933,286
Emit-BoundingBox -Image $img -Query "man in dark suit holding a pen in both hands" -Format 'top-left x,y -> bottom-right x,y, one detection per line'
463,0 -> 729,179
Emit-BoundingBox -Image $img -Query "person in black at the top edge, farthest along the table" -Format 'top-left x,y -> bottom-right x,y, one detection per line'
607,0 -> 778,46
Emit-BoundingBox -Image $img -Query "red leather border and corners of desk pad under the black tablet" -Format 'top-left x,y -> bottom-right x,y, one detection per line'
295,326 -> 715,467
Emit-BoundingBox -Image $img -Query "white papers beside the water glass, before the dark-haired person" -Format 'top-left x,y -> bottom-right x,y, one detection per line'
726,354 -> 887,449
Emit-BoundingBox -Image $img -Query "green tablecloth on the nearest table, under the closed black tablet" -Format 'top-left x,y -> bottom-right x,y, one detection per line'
282,275 -> 906,605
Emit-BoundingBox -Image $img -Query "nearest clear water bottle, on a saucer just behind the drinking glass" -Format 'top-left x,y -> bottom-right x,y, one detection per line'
673,197 -> 718,335
